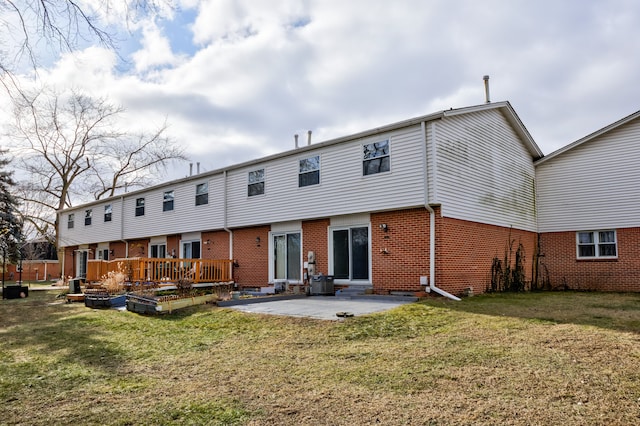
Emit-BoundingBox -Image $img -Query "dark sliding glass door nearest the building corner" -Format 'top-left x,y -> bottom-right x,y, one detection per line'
332,226 -> 369,280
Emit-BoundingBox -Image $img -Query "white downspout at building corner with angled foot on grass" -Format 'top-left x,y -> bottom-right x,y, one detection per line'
420,121 -> 460,301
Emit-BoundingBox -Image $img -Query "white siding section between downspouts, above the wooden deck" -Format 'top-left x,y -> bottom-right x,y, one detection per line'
123,173 -> 224,239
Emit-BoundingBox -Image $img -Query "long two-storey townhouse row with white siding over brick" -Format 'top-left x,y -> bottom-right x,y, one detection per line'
58,102 -> 544,295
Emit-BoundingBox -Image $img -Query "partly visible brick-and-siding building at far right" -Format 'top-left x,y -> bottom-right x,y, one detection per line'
535,111 -> 640,291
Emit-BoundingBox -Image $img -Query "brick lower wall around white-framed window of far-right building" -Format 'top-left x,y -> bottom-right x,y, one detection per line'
540,228 -> 640,291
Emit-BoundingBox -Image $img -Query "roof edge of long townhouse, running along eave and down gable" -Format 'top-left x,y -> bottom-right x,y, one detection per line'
58,101 -> 543,213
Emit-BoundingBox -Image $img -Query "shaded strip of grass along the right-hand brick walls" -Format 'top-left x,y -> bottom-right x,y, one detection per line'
422,291 -> 640,334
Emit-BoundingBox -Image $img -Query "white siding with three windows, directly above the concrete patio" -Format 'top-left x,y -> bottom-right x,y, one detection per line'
227,125 -> 424,228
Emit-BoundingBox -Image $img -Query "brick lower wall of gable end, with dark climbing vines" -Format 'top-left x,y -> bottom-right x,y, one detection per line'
436,214 -> 537,295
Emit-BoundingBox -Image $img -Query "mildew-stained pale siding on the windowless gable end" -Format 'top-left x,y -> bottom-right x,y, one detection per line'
432,109 -> 536,231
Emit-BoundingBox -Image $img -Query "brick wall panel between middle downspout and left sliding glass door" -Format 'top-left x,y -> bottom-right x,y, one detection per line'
233,226 -> 270,287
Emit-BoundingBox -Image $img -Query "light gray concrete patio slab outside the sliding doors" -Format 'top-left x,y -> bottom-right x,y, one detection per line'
225,296 -> 418,320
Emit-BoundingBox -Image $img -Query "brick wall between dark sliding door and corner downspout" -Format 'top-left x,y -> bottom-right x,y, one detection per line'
371,208 -> 429,293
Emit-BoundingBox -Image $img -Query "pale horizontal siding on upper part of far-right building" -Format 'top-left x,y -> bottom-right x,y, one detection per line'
536,115 -> 640,232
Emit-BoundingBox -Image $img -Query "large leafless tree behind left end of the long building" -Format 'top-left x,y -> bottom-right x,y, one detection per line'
7,91 -> 186,246
